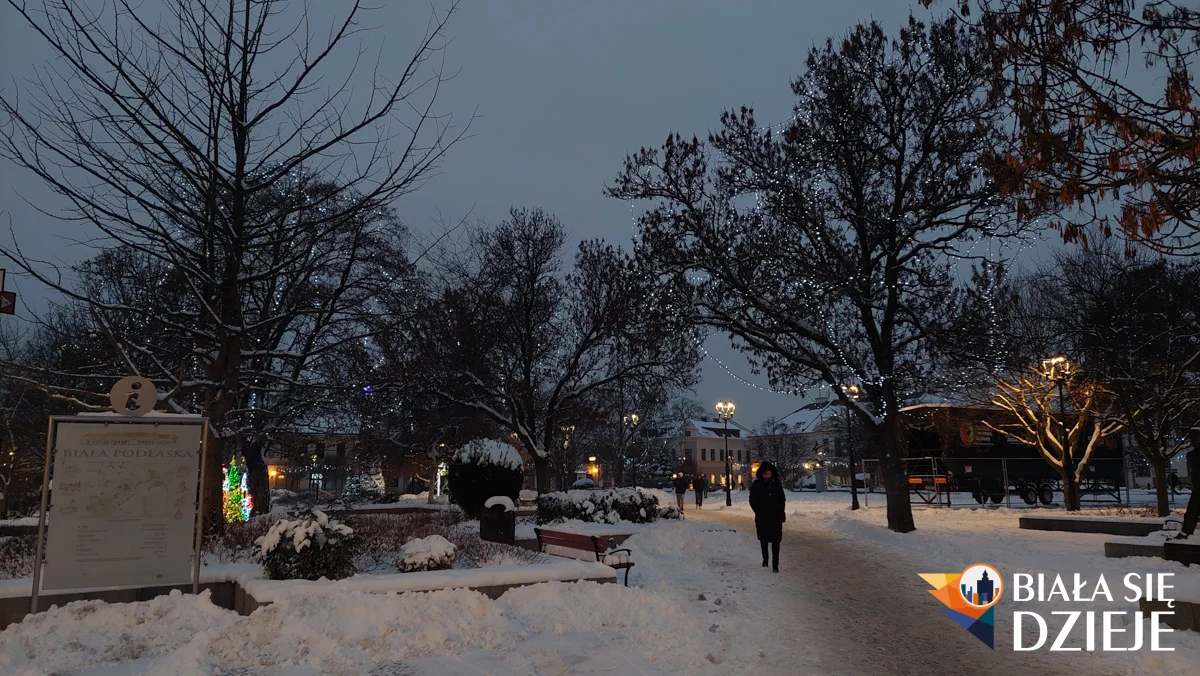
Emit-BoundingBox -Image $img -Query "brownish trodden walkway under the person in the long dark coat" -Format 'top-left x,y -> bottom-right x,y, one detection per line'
688,510 -> 1124,676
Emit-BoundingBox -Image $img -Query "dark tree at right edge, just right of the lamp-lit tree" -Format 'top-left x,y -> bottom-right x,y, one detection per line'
1026,245 -> 1200,516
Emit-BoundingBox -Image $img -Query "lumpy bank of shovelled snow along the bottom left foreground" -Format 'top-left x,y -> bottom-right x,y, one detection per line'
0,582 -> 712,675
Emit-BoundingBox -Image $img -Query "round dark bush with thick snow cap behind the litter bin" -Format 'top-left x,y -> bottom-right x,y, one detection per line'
448,439 -> 524,516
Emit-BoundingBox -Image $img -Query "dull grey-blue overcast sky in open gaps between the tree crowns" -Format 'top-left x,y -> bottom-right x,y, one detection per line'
0,0 -> 928,425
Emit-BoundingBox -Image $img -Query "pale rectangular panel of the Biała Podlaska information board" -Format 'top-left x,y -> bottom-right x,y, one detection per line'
41,418 -> 204,591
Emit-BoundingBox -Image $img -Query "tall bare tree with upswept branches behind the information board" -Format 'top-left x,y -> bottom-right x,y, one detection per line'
0,0 -> 466,525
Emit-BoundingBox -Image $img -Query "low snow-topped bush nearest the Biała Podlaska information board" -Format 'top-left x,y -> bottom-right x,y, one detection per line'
254,512 -> 361,580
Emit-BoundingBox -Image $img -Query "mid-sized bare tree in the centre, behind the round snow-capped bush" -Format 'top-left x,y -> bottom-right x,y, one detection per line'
413,209 -> 698,491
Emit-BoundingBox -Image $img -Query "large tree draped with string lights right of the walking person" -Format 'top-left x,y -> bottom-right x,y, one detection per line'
610,19 -> 1013,532
